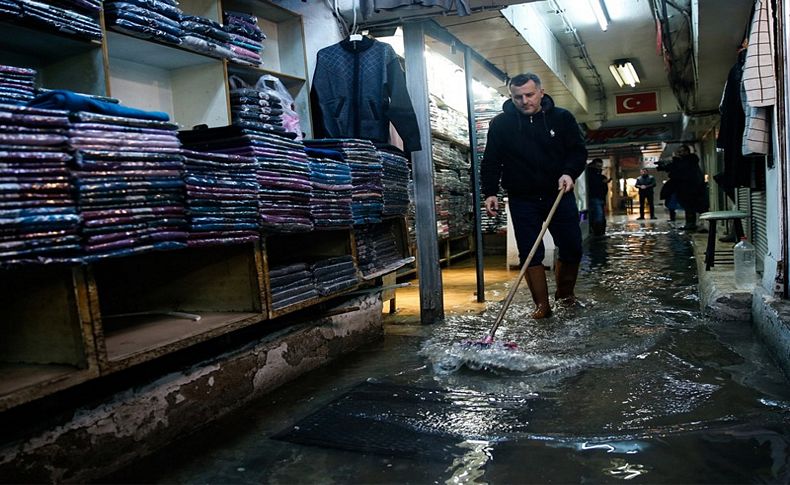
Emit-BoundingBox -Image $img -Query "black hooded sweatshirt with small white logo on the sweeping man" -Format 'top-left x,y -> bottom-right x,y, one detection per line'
480,94 -> 587,198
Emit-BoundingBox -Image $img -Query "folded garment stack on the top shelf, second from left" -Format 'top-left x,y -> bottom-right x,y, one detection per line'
104,0 -> 184,45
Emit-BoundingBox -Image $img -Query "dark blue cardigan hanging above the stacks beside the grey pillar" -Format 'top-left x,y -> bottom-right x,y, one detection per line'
312,37 -> 421,152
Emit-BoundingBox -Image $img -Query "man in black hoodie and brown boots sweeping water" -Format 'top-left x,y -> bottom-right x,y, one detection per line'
480,73 -> 587,319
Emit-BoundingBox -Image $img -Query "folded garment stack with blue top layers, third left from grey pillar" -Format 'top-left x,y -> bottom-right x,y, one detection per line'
305,148 -> 354,229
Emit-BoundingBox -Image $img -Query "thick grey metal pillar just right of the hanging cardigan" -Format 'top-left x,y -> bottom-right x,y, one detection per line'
403,22 -> 444,324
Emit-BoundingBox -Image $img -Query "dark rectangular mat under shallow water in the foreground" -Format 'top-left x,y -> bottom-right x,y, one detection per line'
273,382 -> 524,459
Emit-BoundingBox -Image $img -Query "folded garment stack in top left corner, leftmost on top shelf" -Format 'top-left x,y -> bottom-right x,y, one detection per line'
0,0 -> 102,40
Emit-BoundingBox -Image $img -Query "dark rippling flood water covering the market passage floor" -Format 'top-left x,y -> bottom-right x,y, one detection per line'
108,221 -> 790,484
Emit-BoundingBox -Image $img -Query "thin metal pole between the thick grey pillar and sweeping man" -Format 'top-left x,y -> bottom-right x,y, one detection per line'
464,47 -> 486,303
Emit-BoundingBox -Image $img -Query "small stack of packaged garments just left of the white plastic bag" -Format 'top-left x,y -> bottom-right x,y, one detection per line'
230,86 -> 285,134
